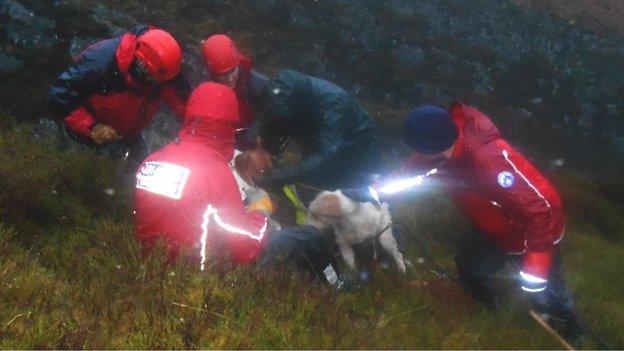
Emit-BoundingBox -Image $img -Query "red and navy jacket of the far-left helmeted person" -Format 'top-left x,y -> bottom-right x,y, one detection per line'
48,27 -> 185,138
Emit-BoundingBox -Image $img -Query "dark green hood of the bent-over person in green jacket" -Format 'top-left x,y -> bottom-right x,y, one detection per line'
267,69 -> 312,122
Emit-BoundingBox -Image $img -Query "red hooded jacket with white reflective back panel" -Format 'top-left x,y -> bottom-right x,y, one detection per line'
134,83 -> 267,264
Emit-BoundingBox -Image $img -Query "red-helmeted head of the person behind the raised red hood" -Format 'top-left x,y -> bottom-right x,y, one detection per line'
202,34 -> 240,89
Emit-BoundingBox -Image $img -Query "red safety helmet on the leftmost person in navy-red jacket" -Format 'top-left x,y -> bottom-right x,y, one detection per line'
134,29 -> 182,82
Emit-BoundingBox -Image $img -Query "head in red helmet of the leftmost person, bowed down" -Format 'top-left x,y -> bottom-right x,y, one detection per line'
130,29 -> 182,84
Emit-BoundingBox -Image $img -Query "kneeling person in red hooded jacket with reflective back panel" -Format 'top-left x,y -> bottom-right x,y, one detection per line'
134,83 -> 335,279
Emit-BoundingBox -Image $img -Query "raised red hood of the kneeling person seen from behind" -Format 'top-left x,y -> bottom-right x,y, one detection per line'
178,82 -> 240,160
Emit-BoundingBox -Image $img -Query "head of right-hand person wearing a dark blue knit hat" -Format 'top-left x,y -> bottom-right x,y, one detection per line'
401,105 -> 459,165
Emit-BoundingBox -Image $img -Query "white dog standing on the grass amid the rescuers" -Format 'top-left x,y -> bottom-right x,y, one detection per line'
307,190 -> 405,272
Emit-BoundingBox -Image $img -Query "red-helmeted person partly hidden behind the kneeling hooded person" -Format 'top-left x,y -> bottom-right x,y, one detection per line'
202,34 -> 269,128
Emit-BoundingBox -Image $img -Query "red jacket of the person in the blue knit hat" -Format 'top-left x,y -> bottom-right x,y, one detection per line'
404,103 -> 565,278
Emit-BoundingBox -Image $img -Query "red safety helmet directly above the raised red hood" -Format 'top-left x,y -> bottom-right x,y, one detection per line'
203,34 -> 240,75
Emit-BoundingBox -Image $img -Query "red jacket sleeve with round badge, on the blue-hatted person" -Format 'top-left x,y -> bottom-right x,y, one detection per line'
477,143 -> 564,279
